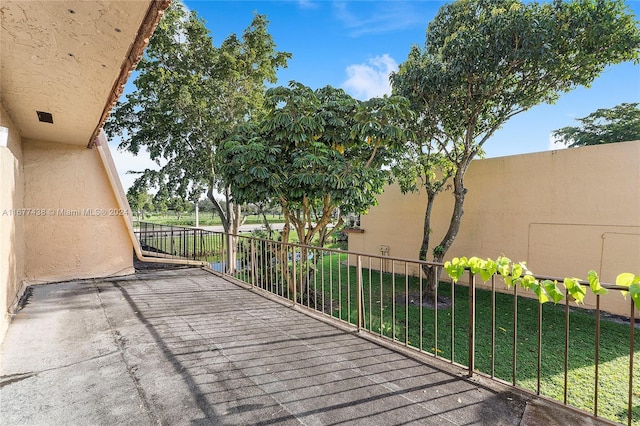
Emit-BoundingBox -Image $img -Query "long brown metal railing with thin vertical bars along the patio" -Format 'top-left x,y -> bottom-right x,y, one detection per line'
134,224 -> 640,425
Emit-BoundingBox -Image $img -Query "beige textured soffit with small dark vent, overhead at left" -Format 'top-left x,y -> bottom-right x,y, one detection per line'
0,0 -> 159,146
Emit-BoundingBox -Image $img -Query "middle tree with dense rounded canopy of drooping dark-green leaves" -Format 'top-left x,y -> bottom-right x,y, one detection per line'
221,82 -> 409,244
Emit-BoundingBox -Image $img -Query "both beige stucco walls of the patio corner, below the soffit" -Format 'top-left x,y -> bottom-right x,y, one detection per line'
0,110 -> 134,341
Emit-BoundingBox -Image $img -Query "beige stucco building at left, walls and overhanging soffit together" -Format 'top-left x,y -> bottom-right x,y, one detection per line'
0,0 -> 170,340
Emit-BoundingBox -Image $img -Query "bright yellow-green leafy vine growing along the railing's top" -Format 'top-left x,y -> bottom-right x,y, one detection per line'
444,256 -> 640,310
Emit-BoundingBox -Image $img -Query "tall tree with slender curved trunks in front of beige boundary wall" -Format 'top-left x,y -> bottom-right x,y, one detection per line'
391,0 -> 640,298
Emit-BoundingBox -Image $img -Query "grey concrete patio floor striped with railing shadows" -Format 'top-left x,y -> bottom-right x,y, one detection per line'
0,269 -> 608,425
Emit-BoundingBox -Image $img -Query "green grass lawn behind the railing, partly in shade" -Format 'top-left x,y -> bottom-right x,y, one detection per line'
245,253 -> 640,424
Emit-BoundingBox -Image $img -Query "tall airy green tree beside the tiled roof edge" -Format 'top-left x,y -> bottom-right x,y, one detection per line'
105,2 -> 291,265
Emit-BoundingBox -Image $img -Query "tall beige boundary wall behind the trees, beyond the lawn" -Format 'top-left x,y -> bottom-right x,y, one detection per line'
349,141 -> 640,315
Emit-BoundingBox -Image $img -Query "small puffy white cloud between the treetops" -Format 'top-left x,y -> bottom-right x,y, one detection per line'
342,53 -> 398,99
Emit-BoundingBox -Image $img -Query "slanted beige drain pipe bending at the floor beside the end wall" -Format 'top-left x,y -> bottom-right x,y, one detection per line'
94,130 -> 211,268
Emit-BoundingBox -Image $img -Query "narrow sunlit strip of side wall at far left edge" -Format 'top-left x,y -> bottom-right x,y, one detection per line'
0,103 -> 25,341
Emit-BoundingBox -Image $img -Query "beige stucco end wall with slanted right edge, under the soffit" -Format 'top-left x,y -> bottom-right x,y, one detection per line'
23,140 -> 133,283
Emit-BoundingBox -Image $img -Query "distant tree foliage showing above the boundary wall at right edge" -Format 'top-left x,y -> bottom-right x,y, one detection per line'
553,103 -> 640,148
